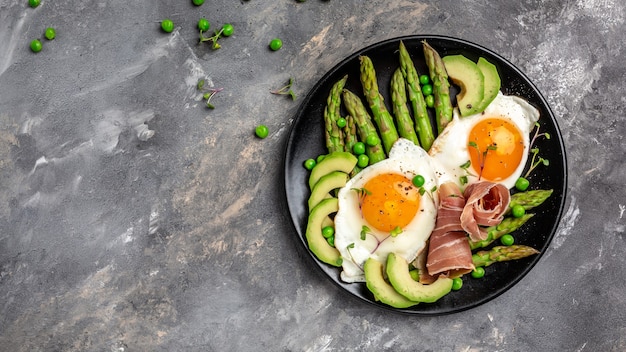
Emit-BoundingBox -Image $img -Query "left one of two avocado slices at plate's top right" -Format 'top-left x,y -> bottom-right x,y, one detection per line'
442,55 -> 485,116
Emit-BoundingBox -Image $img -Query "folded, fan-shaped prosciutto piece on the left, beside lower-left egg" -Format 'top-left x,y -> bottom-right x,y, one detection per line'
426,182 -> 474,277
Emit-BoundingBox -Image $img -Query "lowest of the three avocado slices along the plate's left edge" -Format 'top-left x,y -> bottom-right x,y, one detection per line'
306,197 -> 342,266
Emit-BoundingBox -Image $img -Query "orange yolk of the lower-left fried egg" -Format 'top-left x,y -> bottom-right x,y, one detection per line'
361,173 -> 420,232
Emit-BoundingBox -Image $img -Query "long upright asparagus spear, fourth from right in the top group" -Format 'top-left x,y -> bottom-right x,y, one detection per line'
359,56 -> 398,153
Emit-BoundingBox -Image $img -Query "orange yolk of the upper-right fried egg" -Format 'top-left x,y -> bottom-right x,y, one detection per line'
468,118 -> 524,182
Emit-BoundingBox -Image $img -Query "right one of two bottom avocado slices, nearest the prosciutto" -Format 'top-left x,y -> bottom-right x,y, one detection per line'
387,253 -> 452,303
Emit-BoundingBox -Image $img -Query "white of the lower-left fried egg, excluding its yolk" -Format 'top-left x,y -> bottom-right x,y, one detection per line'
335,138 -> 439,282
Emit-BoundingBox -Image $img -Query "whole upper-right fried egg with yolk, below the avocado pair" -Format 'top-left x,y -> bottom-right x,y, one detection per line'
429,92 -> 539,188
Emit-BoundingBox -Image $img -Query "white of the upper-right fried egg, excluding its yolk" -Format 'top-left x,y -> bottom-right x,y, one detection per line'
428,92 -> 539,188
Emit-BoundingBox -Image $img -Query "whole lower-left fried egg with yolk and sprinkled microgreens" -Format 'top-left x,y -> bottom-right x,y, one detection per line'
335,138 -> 438,282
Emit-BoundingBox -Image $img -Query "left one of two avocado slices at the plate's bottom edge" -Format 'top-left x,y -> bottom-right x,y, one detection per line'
363,257 -> 418,308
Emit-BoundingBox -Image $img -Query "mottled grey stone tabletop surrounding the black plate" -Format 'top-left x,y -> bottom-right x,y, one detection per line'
0,0 -> 626,352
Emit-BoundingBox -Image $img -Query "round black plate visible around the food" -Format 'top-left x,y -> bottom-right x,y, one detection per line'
284,35 -> 567,315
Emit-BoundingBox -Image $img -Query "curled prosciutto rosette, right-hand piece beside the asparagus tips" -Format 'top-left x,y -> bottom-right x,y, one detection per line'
461,181 -> 511,241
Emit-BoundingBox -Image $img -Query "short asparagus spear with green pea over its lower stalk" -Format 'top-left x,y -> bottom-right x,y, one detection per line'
342,89 -> 386,165
